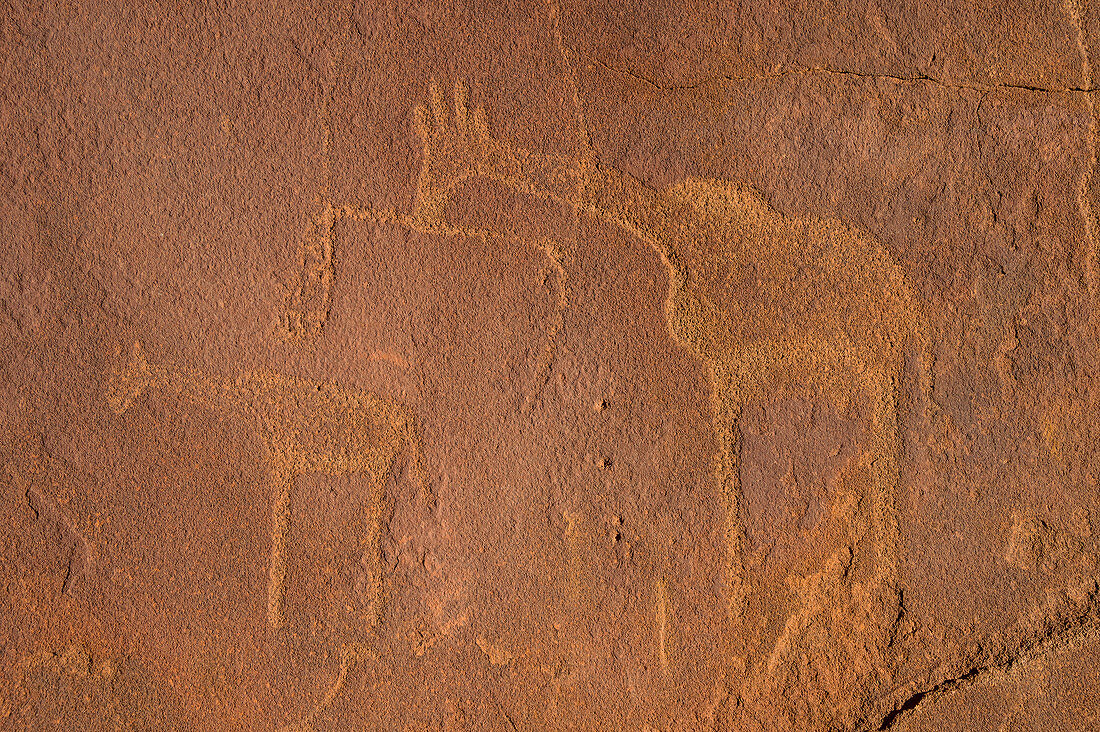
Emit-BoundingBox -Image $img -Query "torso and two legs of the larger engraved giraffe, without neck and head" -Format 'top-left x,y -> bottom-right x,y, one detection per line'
642,178 -> 927,615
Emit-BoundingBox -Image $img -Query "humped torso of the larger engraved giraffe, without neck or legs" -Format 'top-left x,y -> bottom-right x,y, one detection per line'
666,178 -> 920,394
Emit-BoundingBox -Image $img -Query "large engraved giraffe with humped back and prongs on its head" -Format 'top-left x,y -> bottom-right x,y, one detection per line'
413,84 -> 931,619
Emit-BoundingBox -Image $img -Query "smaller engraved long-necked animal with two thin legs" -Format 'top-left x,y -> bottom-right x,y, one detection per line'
107,343 -> 420,629
